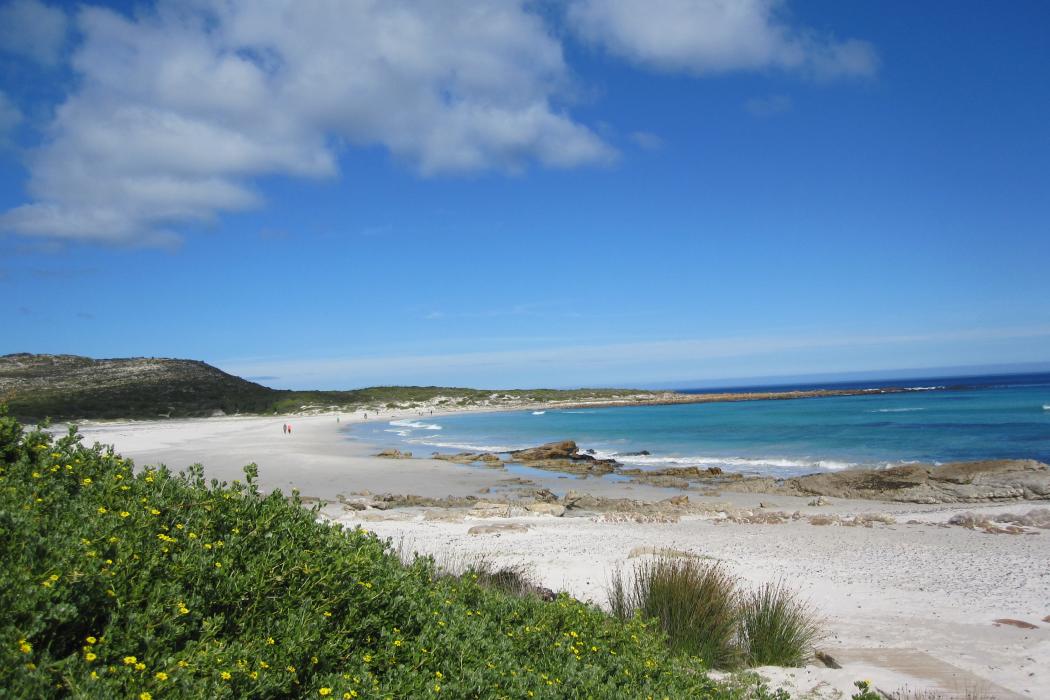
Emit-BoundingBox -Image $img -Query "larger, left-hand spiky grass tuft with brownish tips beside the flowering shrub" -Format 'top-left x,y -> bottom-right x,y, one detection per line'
609,557 -> 740,669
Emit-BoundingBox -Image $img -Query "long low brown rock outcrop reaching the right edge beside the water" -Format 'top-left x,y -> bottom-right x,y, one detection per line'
722,460 -> 1050,504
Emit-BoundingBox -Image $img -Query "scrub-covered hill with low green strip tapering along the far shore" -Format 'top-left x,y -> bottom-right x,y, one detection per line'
0,354 -> 637,420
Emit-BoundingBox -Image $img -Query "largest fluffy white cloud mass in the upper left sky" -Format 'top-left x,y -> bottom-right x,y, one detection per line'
0,0 -> 615,243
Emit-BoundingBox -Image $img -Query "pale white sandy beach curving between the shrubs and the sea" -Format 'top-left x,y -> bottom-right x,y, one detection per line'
67,411 -> 1050,698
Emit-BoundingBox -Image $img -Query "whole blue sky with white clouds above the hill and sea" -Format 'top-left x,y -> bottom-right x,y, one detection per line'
0,0 -> 1050,388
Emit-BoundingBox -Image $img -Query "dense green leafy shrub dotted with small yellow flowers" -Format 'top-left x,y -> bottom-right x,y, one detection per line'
0,413 -> 782,700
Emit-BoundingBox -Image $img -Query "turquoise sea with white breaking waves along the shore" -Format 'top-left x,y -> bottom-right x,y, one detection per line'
354,375 -> 1050,476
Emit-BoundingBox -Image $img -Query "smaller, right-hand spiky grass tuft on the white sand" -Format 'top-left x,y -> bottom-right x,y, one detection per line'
740,582 -> 820,666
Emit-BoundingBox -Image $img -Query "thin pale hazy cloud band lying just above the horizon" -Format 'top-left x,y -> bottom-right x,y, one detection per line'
216,325 -> 1050,388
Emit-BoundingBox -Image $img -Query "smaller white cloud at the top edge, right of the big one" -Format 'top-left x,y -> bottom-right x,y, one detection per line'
568,0 -> 877,78
